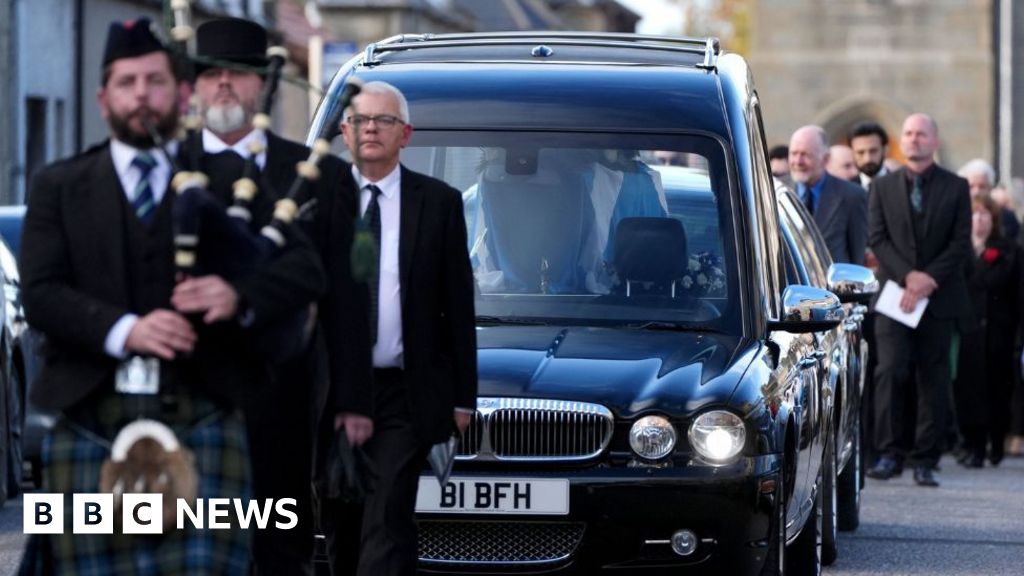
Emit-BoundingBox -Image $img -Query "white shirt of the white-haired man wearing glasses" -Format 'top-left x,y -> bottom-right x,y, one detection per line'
352,164 -> 404,368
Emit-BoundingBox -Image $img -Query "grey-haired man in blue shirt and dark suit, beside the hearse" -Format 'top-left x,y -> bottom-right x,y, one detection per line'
790,126 -> 867,264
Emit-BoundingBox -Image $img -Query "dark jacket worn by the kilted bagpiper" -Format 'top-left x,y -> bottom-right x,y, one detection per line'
19,138 -> 324,410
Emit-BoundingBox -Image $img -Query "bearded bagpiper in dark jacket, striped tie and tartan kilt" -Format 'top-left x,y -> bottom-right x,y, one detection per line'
20,19 -> 325,575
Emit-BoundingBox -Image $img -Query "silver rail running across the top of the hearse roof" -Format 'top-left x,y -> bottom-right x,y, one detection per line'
362,31 -> 721,70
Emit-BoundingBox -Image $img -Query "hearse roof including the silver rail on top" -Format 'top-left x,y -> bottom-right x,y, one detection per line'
317,32 -> 730,139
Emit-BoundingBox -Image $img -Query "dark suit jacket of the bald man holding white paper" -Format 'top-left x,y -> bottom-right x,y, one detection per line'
868,166 -> 972,319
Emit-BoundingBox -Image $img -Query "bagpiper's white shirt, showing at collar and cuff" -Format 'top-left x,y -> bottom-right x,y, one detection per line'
103,138 -> 177,358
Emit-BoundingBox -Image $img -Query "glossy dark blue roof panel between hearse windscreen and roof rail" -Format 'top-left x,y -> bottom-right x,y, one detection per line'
357,63 -> 727,135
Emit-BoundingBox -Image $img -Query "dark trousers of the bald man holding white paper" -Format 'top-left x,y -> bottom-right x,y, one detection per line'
874,314 -> 953,467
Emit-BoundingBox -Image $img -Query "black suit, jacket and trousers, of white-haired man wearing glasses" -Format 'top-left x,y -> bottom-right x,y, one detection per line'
324,163 -> 477,576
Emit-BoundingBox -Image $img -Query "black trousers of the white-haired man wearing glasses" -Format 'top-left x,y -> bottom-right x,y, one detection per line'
357,369 -> 430,576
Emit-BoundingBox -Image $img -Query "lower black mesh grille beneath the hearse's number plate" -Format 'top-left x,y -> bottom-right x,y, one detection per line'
419,521 -> 584,565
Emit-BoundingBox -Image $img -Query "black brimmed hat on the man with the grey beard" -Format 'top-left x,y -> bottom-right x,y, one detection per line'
196,18 -> 267,74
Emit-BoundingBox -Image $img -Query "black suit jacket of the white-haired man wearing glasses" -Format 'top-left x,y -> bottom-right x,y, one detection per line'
323,166 -> 477,443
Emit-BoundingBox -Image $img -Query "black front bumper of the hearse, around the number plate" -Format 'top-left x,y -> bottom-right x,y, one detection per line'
418,455 -> 781,574
